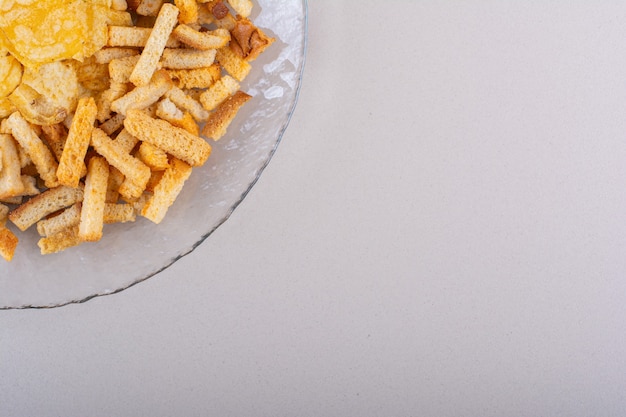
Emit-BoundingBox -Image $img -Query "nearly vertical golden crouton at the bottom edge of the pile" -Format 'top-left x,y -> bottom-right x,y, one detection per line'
78,156 -> 109,242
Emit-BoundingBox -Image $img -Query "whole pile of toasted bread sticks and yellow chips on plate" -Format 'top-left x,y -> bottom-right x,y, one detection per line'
0,0 -> 274,260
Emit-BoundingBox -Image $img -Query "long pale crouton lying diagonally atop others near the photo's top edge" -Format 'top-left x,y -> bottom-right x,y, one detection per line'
129,3 -> 178,86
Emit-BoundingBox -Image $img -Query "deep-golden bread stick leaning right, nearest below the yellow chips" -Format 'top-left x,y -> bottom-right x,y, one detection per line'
57,97 -> 98,187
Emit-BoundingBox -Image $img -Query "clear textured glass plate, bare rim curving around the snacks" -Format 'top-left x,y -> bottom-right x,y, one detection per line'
0,0 -> 307,309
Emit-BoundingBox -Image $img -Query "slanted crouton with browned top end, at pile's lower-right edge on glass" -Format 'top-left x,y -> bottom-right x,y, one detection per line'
141,158 -> 192,224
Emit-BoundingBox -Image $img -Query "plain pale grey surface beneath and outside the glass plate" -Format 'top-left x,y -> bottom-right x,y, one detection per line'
0,0 -> 626,417
